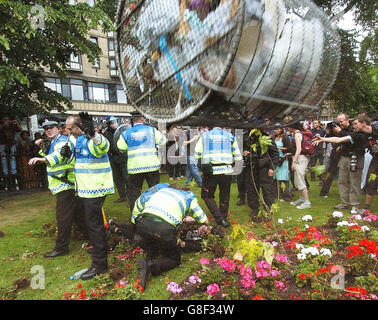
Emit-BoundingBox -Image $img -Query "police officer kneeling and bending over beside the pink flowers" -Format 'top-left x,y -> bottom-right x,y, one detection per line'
131,183 -> 208,289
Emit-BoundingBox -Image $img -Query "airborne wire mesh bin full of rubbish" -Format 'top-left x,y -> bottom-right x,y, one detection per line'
116,0 -> 340,127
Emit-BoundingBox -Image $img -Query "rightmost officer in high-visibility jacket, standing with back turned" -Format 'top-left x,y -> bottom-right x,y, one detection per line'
194,127 -> 243,228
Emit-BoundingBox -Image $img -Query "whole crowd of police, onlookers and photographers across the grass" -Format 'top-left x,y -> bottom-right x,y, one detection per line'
0,112 -> 378,287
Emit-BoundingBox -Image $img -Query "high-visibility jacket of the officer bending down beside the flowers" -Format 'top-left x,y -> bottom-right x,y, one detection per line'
131,183 -> 207,227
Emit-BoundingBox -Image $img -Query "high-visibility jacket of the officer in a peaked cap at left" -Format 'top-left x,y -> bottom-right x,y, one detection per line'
39,134 -> 75,195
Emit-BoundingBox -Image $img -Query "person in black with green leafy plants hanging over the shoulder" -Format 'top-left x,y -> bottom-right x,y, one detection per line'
246,129 -> 279,222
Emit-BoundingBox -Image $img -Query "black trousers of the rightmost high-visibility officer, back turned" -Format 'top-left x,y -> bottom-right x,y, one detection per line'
201,174 -> 232,223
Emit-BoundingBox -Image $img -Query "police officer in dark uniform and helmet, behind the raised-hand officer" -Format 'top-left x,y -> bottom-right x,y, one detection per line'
104,116 -> 131,203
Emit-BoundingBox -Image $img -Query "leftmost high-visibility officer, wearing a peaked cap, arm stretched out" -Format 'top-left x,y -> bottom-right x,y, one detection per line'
29,116 -> 87,258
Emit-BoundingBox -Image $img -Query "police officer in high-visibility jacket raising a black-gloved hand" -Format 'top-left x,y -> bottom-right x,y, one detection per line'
62,112 -> 114,280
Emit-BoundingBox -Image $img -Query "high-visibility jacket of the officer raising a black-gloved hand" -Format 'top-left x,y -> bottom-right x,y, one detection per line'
75,135 -> 114,198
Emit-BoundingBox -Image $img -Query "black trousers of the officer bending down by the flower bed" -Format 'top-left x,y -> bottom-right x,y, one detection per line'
136,216 -> 181,276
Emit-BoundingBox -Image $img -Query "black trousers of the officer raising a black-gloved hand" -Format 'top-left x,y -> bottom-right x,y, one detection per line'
82,196 -> 108,269
